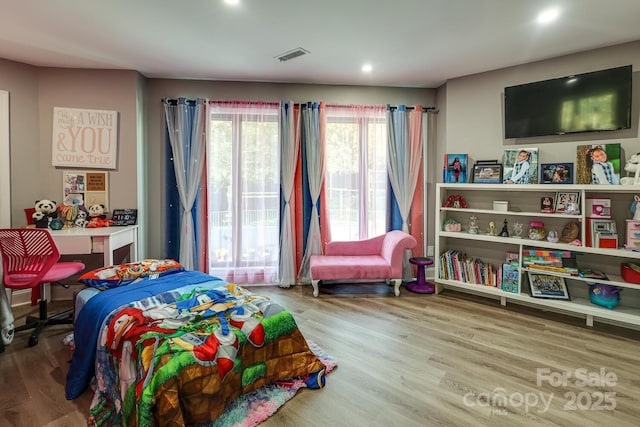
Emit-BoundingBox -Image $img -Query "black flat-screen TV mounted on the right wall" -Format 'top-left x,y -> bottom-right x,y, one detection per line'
504,65 -> 632,138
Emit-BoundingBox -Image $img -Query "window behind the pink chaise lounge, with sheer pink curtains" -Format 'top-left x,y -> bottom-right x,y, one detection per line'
325,106 -> 388,240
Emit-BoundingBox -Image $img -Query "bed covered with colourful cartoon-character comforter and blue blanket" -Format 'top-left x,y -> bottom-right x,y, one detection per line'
65,270 -> 325,426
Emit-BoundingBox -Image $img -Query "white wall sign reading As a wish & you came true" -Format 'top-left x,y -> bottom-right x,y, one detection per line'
51,107 -> 118,169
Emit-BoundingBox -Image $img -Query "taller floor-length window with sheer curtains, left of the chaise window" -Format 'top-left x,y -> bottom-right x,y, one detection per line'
207,102 -> 280,283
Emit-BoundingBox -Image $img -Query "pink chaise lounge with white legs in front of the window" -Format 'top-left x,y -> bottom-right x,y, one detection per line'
310,230 -> 418,297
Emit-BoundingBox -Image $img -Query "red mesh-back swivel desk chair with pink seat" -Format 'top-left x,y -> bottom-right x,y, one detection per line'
0,228 -> 85,347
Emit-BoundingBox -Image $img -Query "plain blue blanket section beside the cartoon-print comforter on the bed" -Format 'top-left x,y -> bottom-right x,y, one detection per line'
65,271 -> 220,400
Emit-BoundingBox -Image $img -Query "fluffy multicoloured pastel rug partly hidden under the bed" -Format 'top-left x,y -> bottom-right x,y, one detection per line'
203,340 -> 337,427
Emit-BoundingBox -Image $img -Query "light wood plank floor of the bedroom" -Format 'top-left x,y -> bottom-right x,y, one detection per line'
0,284 -> 640,427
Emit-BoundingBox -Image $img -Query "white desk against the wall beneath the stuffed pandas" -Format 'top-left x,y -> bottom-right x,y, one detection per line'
49,225 -> 138,267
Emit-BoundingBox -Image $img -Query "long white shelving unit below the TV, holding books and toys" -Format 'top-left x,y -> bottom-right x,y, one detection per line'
435,183 -> 640,329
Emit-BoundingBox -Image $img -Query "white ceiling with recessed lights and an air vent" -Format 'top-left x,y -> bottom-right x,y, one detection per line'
0,0 -> 640,88
